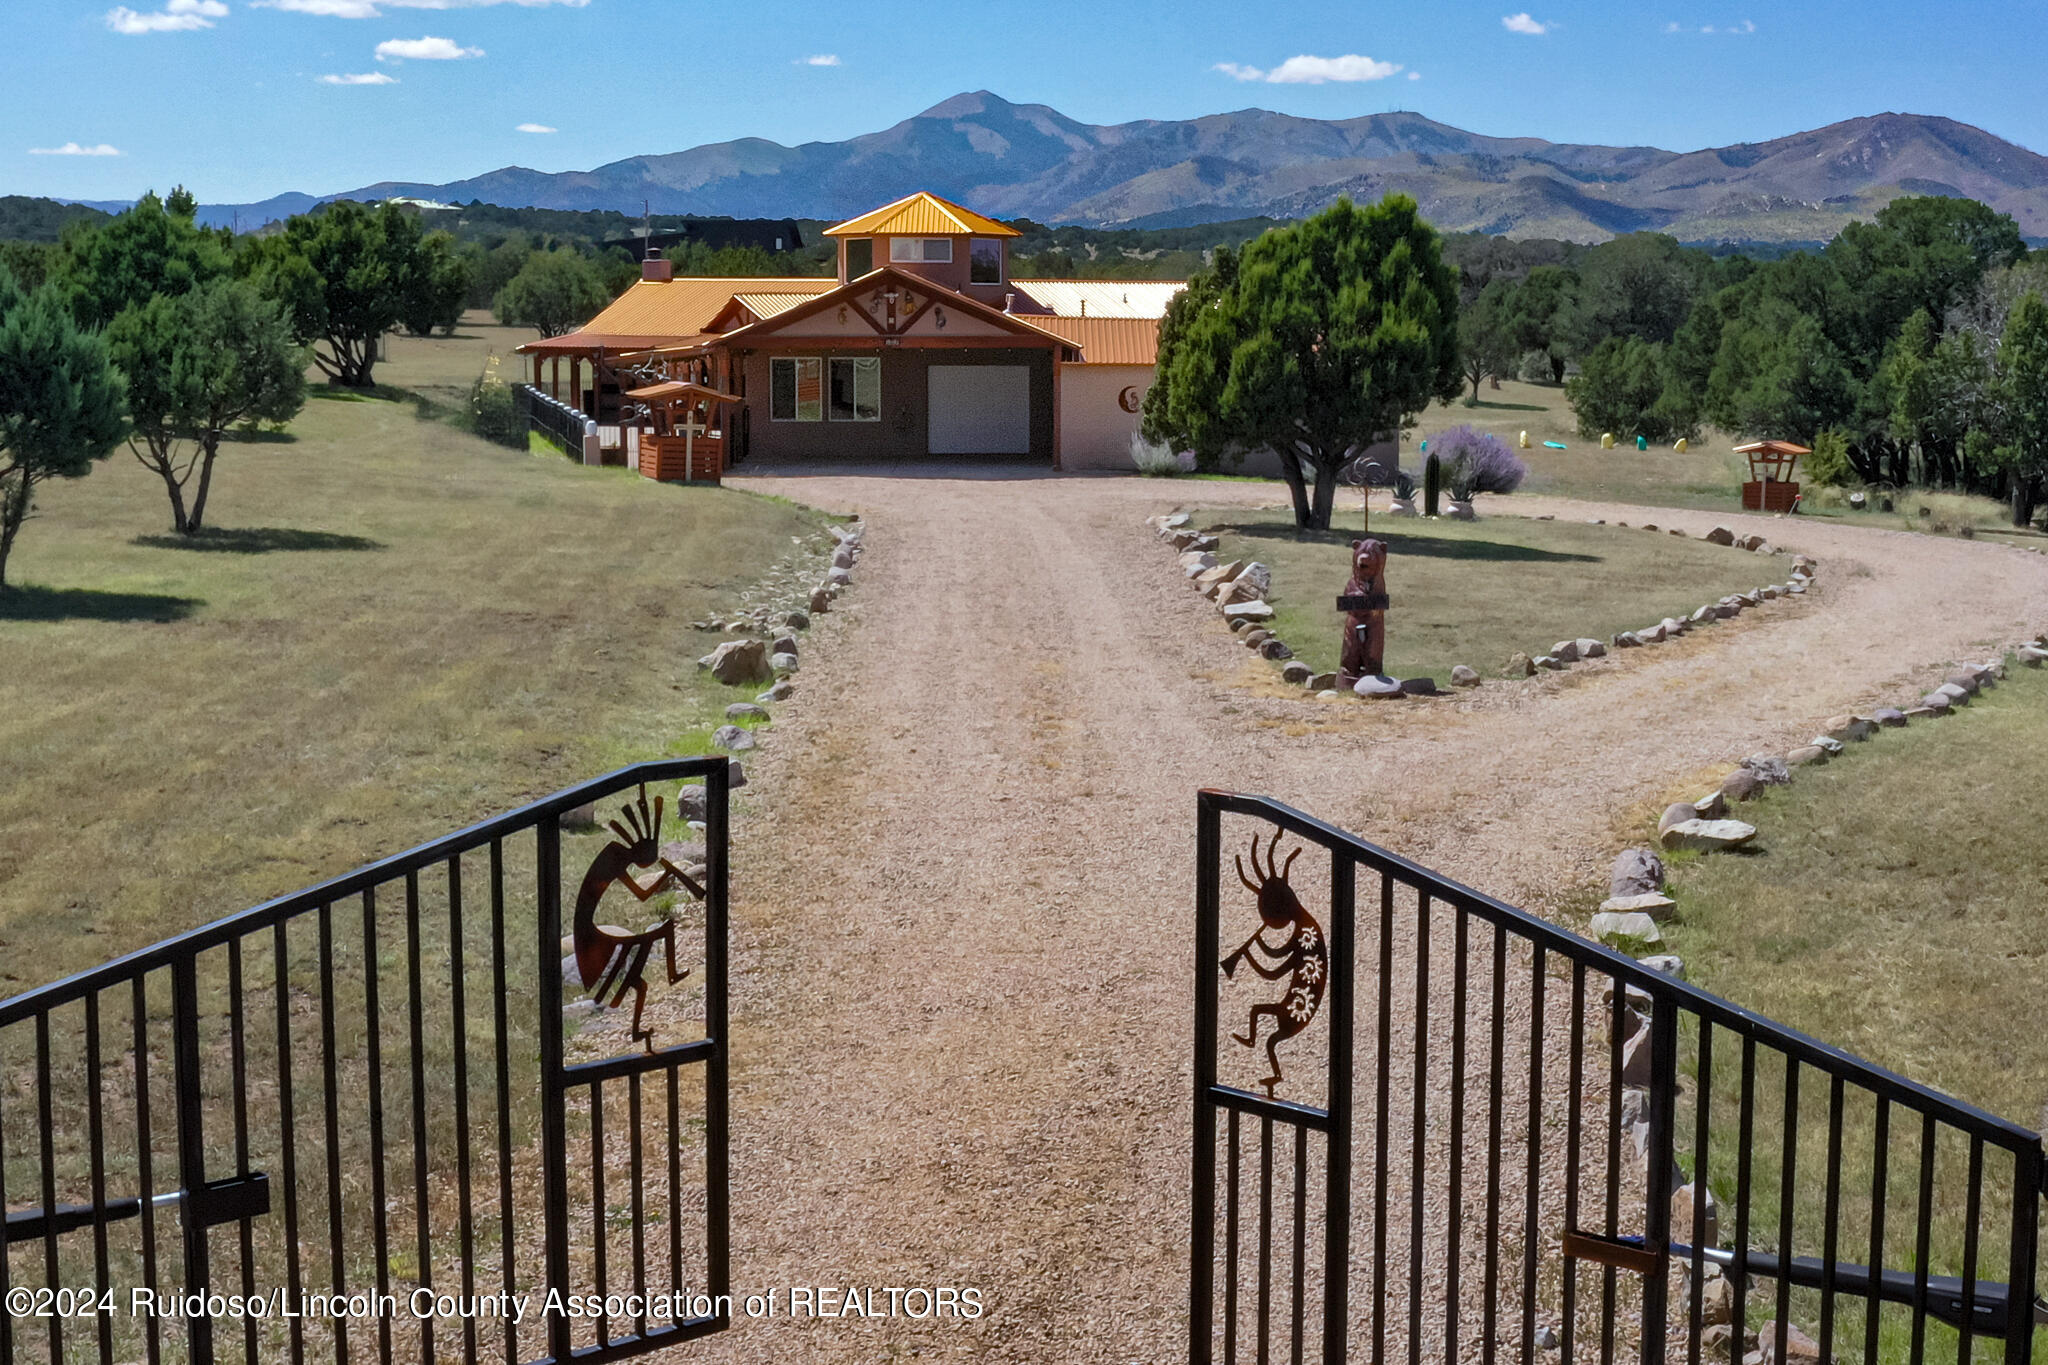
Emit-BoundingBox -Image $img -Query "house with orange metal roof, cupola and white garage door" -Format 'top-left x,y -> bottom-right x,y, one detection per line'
520,192 -> 1182,469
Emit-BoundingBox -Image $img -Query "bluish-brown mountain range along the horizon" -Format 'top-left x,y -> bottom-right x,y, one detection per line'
72,90 -> 2048,244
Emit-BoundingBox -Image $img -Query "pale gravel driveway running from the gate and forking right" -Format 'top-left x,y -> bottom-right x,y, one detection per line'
655,467 -> 2048,1365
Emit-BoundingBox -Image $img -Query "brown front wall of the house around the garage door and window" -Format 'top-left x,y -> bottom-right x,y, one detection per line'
737,344 -> 1053,469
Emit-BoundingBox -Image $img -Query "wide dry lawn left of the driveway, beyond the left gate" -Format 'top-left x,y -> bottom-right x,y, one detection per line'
0,368 -> 831,993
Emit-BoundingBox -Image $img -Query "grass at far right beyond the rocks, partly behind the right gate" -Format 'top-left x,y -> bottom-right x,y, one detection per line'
1663,669 -> 2048,1359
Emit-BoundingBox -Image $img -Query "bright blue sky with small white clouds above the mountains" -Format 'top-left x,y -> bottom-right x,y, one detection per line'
0,0 -> 2048,203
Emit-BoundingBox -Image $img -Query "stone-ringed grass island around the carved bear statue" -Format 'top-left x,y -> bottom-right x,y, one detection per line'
1196,499 -> 1786,684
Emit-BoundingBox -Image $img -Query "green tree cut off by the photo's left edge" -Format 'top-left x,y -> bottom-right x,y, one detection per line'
0,272 -> 123,591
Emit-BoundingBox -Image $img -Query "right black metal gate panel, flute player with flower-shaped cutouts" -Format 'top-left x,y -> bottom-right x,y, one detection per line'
1188,792 -> 2044,1365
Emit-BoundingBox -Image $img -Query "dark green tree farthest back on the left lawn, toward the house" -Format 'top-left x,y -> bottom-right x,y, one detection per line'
246,201 -> 420,389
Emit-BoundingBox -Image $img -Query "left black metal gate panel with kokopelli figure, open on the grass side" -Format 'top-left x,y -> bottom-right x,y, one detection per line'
0,759 -> 731,1365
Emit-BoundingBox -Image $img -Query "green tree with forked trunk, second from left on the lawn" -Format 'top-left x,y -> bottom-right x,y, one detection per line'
106,280 -> 305,536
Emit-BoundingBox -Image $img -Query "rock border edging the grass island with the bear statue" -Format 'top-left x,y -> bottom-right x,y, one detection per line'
1145,512 -> 1821,698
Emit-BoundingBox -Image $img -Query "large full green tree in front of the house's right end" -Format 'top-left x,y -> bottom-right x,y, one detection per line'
1149,194 -> 1460,530
